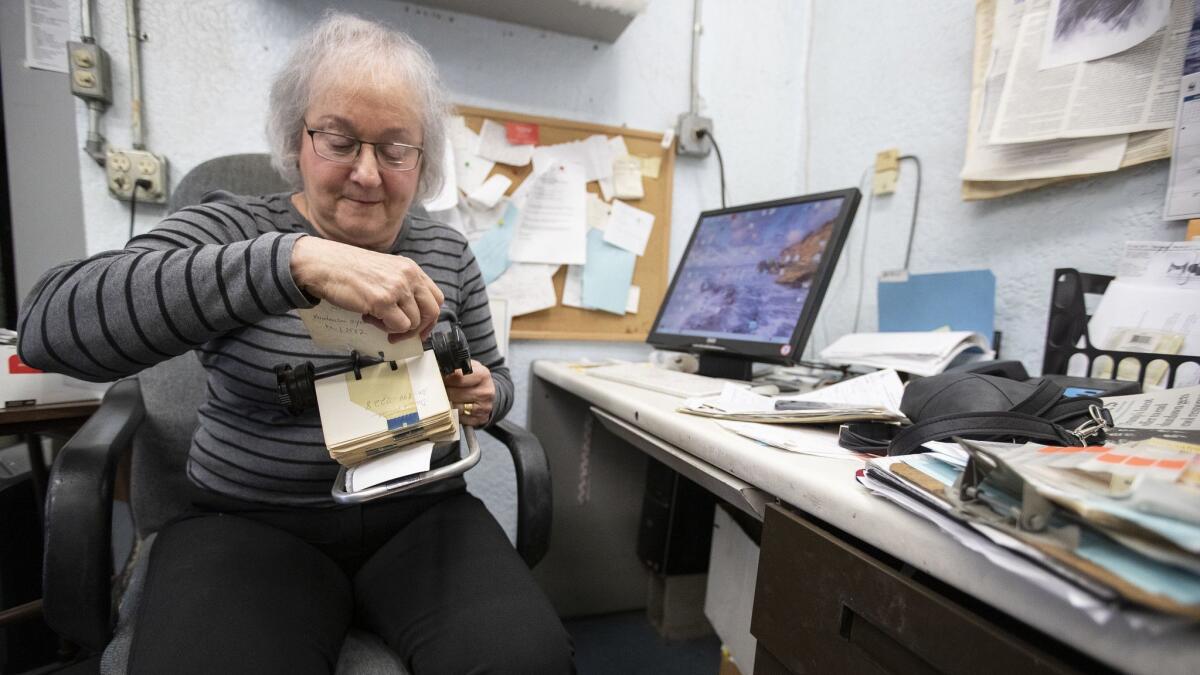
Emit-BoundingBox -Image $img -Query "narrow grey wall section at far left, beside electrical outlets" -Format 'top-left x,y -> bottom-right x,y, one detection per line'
0,2 -> 84,301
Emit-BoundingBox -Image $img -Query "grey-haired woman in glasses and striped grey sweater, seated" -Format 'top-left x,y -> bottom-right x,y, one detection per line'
19,13 -> 571,675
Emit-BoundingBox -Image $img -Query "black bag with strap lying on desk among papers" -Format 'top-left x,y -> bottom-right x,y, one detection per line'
838,372 -> 1112,455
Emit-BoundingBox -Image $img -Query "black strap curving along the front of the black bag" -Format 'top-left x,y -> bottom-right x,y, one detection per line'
888,412 -> 1084,456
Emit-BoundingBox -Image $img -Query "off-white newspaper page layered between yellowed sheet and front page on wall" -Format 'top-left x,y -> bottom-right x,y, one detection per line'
962,0 -> 1128,180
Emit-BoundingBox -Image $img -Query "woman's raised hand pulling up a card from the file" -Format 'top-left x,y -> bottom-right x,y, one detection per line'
292,237 -> 446,341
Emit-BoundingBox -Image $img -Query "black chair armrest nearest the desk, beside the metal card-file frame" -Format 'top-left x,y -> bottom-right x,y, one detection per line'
485,420 -> 554,569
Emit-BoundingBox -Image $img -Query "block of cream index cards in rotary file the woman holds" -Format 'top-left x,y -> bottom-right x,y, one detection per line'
317,352 -> 457,466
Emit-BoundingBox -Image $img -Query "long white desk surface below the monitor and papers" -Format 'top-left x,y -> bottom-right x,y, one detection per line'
533,360 -> 1200,675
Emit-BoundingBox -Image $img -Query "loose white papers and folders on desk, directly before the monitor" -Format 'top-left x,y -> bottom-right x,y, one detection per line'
679,370 -> 907,424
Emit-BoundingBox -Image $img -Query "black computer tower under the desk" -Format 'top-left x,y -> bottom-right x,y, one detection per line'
637,458 -> 716,575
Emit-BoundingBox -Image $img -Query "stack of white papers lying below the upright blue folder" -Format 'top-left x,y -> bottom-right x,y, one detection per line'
821,330 -> 996,376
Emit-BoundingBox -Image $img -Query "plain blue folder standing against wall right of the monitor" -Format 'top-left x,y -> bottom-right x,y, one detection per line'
878,269 -> 996,345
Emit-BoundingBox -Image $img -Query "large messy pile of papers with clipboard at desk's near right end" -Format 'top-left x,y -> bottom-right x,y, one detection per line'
859,387 -> 1200,629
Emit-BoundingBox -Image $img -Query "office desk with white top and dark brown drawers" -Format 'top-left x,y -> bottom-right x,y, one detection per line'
529,360 -> 1200,674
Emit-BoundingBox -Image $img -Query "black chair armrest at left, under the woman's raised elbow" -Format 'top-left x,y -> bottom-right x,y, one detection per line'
42,378 -> 145,651
